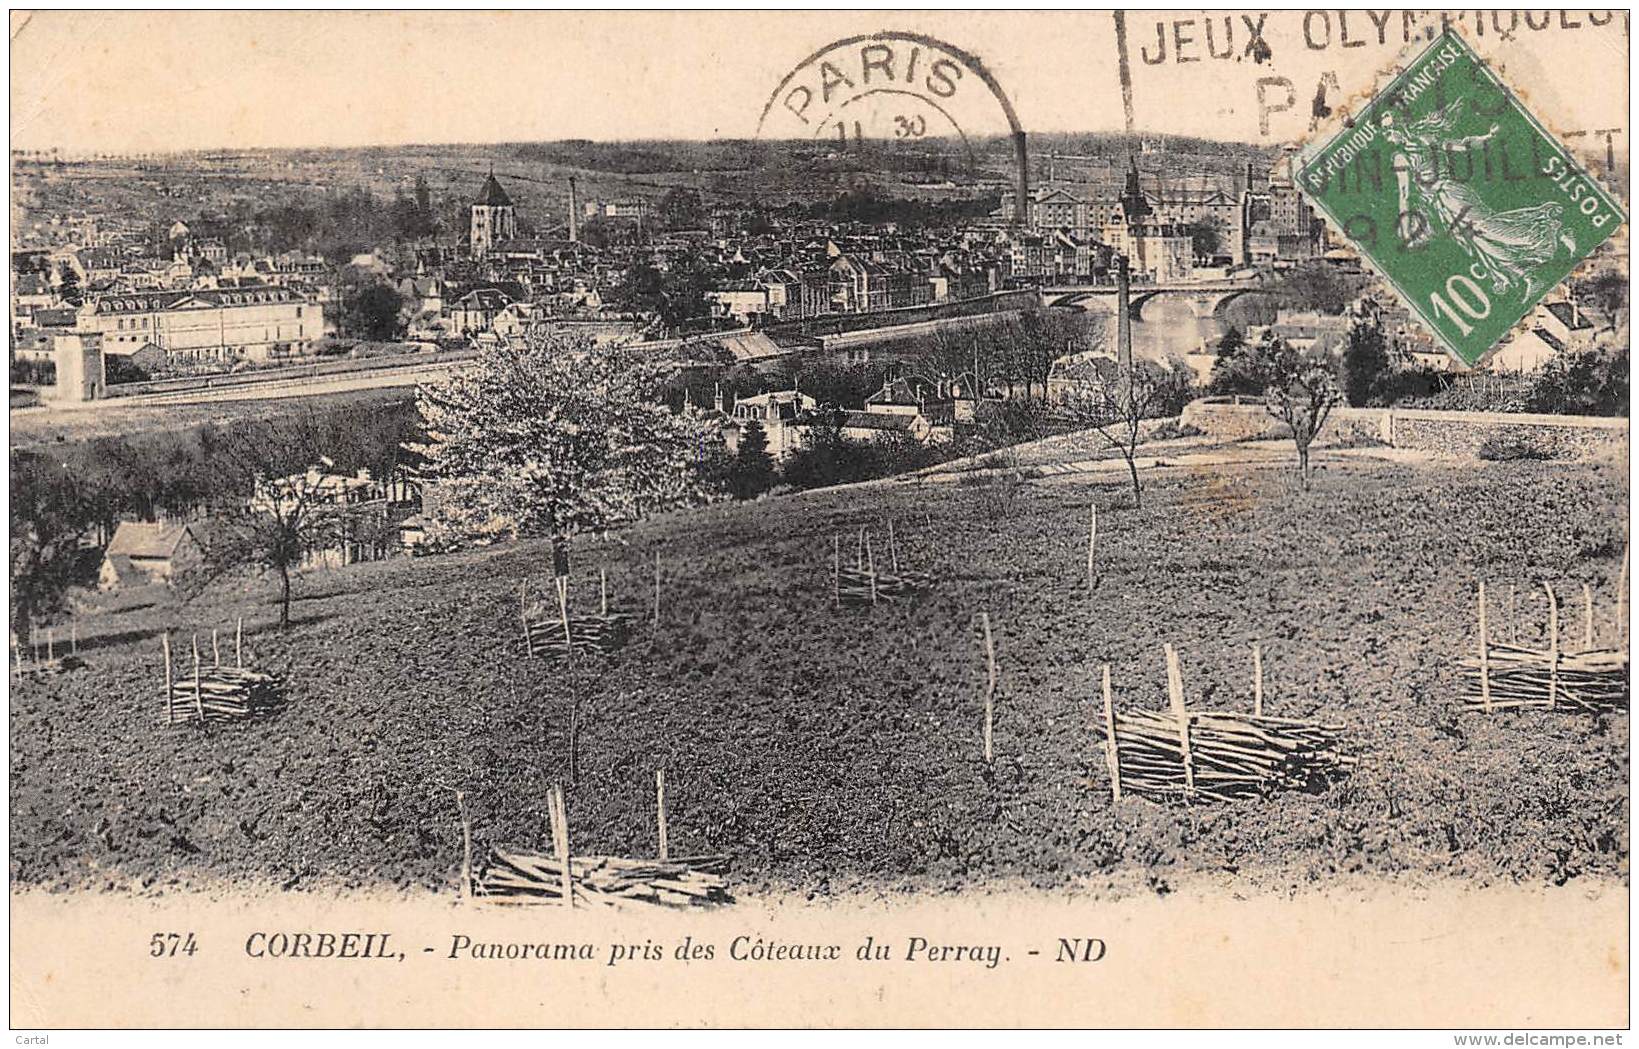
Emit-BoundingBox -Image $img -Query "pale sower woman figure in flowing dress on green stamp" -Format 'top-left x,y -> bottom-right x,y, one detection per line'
1382,98 -> 1577,298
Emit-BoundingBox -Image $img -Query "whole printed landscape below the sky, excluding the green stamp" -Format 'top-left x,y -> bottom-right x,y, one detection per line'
10,10 -> 1629,901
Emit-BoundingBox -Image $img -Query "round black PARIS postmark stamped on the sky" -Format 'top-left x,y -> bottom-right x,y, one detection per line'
757,31 -> 1029,204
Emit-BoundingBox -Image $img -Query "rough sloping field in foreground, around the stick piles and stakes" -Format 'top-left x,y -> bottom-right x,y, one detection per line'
11,462 -> 1628,892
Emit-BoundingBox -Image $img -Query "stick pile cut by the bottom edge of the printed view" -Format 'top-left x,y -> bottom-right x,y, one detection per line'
472,846 -> 731,906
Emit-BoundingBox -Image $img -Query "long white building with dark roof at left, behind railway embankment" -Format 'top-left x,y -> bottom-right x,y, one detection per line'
75,287 -> 325,361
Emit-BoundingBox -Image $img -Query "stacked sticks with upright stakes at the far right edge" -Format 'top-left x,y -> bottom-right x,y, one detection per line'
1457,576 -> 1628,713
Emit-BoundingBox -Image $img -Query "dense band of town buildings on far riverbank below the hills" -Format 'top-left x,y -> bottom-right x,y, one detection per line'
10,140 -> 1619,398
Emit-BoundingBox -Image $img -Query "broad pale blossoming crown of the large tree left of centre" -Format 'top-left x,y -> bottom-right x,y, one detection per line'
413,329 -> 705,570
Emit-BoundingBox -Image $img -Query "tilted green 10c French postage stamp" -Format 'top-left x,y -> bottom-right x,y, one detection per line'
1298,30 -> 1624,366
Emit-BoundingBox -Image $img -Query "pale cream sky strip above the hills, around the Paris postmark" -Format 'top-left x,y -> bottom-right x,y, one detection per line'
11,10 -> 1629,154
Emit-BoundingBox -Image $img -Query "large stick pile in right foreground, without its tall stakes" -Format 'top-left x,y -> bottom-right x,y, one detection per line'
1115,710 -> 1355,802
